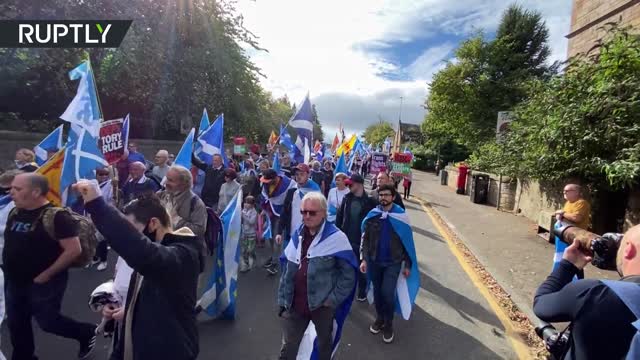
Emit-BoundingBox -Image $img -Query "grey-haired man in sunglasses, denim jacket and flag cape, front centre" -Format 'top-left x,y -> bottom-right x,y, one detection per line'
278,192 -> 357,360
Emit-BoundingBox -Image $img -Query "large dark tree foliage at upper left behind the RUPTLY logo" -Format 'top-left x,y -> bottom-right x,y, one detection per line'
0,0 -> 291,142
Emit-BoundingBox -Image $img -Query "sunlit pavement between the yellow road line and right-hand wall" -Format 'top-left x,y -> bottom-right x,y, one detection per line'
411,170 -> 619,323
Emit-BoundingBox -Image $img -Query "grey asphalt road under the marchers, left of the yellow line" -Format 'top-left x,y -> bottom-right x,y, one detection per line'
1,197 -> 517,360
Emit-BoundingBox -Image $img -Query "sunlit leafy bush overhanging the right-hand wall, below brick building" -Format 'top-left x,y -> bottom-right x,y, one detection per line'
472,28 -> 640,190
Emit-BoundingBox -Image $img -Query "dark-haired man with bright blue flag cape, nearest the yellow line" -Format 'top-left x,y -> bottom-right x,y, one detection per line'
360,184 -> 420,344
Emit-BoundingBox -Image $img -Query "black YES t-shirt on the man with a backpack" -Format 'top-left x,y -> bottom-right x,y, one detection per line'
2,204 -> 78,282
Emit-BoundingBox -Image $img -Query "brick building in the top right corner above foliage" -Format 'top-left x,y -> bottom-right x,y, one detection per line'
567,0 -> 640,57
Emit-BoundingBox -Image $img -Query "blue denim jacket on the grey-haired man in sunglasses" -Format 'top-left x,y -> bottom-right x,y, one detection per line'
278,224 -> 356,311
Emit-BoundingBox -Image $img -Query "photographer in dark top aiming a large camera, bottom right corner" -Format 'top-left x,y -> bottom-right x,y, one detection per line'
533,225 -> 640,359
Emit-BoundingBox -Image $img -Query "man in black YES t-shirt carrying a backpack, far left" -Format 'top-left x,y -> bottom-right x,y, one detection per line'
2,173 -> 96,360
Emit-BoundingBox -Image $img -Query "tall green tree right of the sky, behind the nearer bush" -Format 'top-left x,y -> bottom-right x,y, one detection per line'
422,5 -> 556,149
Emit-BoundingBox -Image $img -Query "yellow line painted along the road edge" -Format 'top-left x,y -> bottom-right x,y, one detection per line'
414,196 -> 533,360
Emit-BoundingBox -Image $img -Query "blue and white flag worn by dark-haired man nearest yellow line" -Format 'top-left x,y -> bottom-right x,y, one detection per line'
361,204 -> 420,320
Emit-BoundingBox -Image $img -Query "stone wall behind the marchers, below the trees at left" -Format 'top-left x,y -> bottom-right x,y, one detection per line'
0,130 -> 182,169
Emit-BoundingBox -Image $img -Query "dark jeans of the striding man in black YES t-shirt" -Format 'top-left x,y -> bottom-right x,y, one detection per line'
5,271 -> 95,360
